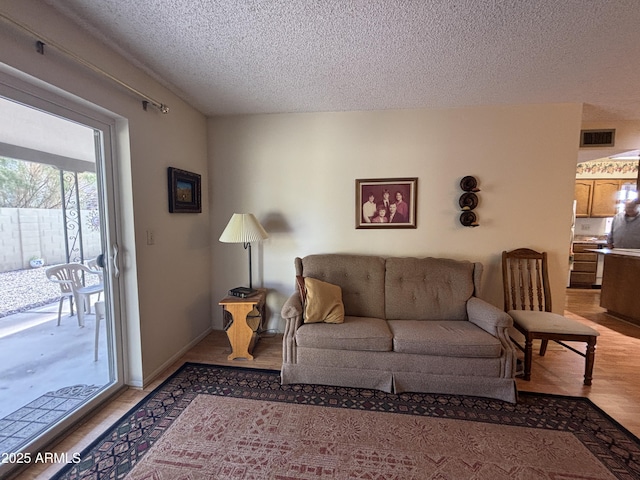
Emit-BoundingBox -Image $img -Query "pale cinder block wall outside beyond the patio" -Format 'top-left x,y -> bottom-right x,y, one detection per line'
0,208 -> 101,272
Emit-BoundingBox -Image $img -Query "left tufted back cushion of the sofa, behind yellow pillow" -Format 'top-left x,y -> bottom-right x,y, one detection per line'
295,254 -> 385,318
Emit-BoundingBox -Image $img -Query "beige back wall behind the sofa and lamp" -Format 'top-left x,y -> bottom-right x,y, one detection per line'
209,104 -> 582,328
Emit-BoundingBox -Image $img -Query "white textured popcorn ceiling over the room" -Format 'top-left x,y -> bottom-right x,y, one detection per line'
46,0 -> 640,121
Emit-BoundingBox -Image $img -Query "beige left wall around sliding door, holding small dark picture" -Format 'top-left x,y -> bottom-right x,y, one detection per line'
0,0 -> 211,385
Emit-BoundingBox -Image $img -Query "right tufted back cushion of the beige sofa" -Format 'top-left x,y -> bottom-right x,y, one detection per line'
385,258 -> 475,320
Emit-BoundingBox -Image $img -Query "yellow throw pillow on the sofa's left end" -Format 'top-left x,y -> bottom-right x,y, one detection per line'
304,277 -> 344,323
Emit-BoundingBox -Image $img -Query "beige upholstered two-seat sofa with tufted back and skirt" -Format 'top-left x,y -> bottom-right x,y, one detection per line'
281,254 -> 517,402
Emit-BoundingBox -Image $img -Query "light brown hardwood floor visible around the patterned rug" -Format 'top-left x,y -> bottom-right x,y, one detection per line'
17,289 -> 640,479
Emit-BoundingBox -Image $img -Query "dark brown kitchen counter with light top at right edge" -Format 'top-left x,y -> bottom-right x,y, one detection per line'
594,248 -> 640,325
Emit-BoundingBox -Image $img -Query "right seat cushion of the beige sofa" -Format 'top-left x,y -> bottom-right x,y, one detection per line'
388,320 -> 502,358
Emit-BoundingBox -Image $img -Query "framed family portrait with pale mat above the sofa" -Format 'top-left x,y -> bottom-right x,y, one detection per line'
356,178 -> 418,228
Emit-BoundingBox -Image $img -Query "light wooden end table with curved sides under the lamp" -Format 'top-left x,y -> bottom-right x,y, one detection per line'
218,288 -> 267,360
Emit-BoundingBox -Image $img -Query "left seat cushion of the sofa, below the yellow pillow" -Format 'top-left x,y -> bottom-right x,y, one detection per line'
296,316 -> 393,352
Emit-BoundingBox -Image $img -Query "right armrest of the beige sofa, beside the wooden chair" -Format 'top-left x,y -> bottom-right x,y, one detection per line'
467,297 -> 517,378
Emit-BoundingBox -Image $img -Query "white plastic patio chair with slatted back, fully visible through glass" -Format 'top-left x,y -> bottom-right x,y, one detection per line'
45,263 -> 104,327
